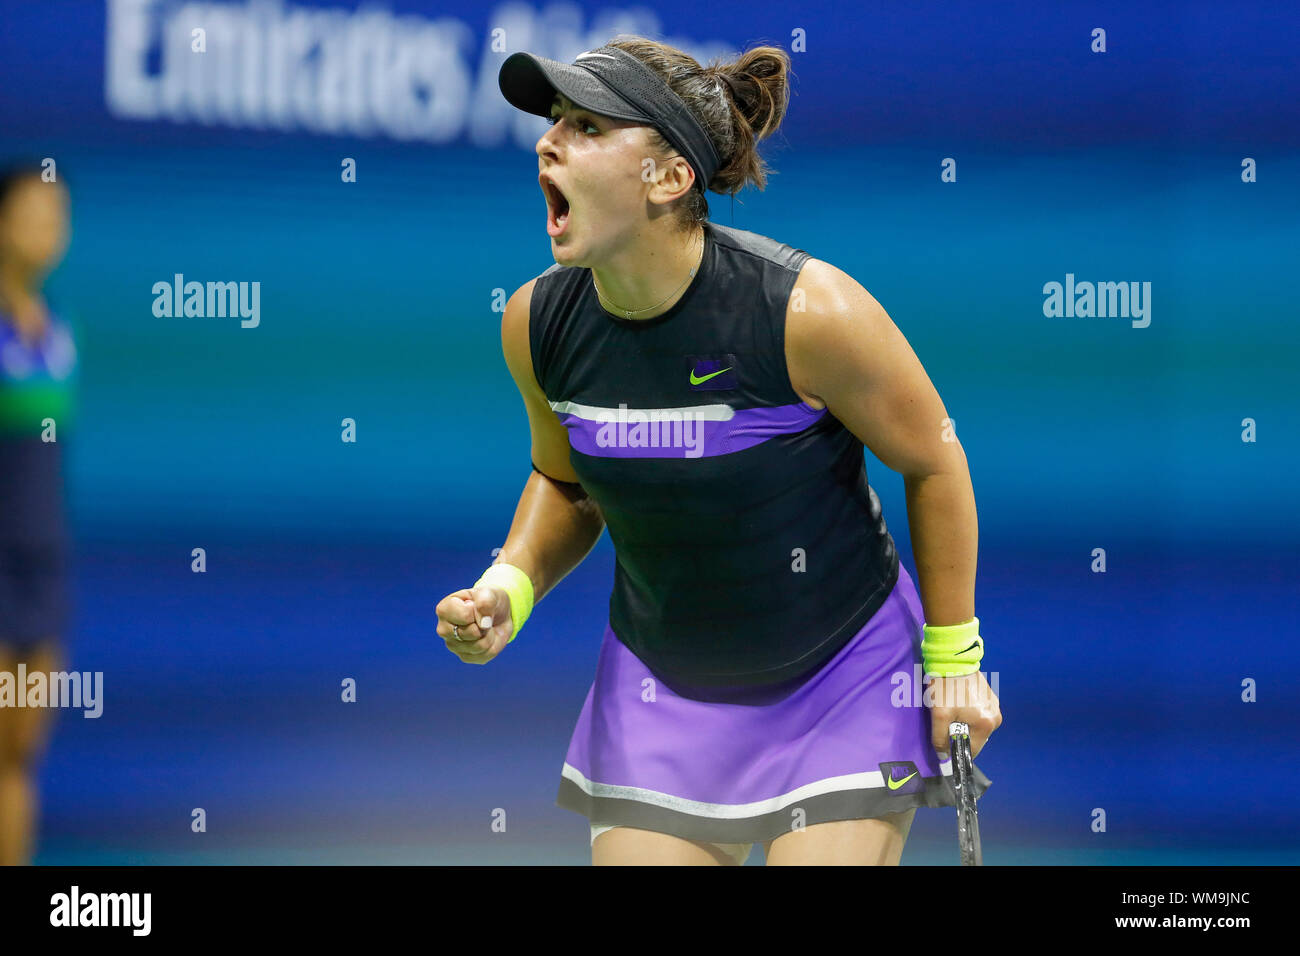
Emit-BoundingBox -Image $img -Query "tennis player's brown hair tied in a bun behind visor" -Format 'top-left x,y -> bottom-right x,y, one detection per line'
608,35 -> 790,228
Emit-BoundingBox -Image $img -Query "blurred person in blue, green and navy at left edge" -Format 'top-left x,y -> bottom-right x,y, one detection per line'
0,165 -> 77,865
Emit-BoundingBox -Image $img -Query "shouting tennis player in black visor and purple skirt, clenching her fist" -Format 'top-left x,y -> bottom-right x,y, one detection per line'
437,36 -> 1001,865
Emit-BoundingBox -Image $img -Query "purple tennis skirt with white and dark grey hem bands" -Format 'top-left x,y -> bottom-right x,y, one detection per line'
555,564 -> 991,843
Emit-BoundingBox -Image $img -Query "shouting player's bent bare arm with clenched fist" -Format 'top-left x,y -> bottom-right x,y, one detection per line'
437,278 -> 605,663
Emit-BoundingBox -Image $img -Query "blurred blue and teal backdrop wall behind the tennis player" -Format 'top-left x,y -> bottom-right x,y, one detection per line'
0,1 -> 1300,862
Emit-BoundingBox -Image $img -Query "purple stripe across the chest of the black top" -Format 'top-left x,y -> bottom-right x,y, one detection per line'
556,402 -> 827,458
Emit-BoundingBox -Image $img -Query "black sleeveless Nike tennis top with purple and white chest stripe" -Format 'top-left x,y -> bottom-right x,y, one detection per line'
529,222 -> 898,700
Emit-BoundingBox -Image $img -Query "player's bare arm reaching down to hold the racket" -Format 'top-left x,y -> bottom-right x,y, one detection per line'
785,259 -> 1001,750
